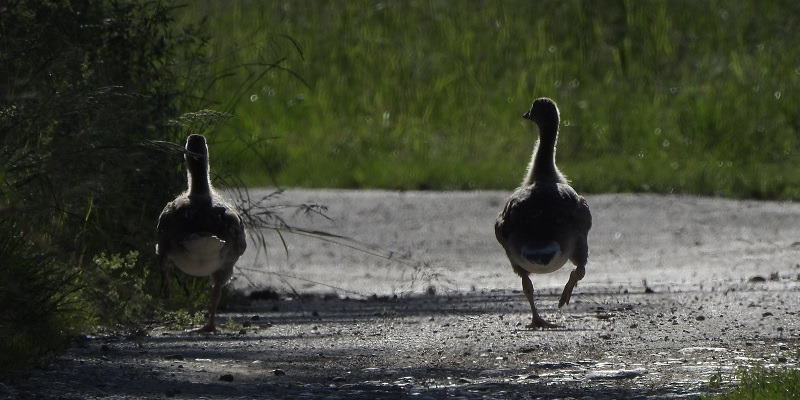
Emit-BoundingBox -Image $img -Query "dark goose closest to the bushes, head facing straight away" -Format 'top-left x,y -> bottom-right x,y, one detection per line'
156,135 -> 247,332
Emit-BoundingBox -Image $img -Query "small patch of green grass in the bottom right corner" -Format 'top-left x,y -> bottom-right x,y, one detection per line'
707,368 -> 800,400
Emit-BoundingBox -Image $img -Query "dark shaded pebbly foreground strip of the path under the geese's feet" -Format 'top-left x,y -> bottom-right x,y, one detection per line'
10,285 -> 800,399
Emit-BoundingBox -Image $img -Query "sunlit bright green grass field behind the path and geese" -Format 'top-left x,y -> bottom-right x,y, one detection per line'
181,0 -> 800,199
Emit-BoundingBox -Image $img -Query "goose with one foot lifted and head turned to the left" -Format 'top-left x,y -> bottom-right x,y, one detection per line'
494,98 -> 592,328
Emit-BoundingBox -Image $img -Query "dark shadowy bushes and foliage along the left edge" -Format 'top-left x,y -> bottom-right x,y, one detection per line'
0,0 -> 217,369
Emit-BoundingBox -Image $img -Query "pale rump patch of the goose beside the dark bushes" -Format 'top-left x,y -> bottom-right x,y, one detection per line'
167,236 -> 225,276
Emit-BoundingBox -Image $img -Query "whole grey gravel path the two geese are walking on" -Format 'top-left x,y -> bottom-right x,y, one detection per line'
6,191 -> 800,399
